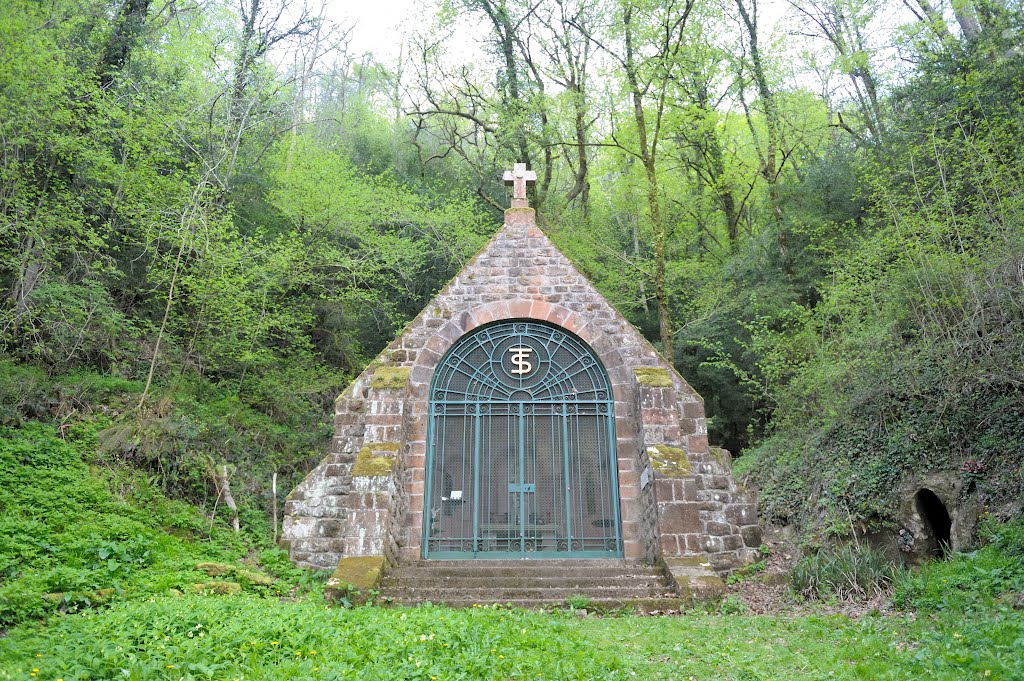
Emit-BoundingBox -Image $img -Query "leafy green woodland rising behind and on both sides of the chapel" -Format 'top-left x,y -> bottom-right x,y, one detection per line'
0,0 -> 1024,531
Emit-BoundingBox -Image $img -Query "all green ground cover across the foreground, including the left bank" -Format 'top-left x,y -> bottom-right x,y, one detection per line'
0,424 -> 1024,681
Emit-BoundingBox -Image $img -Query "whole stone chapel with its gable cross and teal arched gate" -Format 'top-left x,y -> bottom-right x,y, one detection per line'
283,164 -> 761,602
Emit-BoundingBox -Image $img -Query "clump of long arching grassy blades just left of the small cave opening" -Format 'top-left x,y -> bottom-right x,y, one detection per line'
790,542 -> 897,599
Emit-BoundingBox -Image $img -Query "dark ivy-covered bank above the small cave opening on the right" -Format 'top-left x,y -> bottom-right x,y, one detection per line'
740,374 -> 1024,535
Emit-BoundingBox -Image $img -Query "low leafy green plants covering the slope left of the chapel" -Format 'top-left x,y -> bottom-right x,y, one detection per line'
0,423 -> 322,626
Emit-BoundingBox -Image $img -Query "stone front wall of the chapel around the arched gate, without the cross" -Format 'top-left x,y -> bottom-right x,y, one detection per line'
283,208 -> 761,573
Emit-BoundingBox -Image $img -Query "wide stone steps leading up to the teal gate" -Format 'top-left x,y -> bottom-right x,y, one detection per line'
378,559 -> 680,610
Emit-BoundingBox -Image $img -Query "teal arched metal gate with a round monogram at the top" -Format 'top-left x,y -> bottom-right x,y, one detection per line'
423,321 -> 623,558
